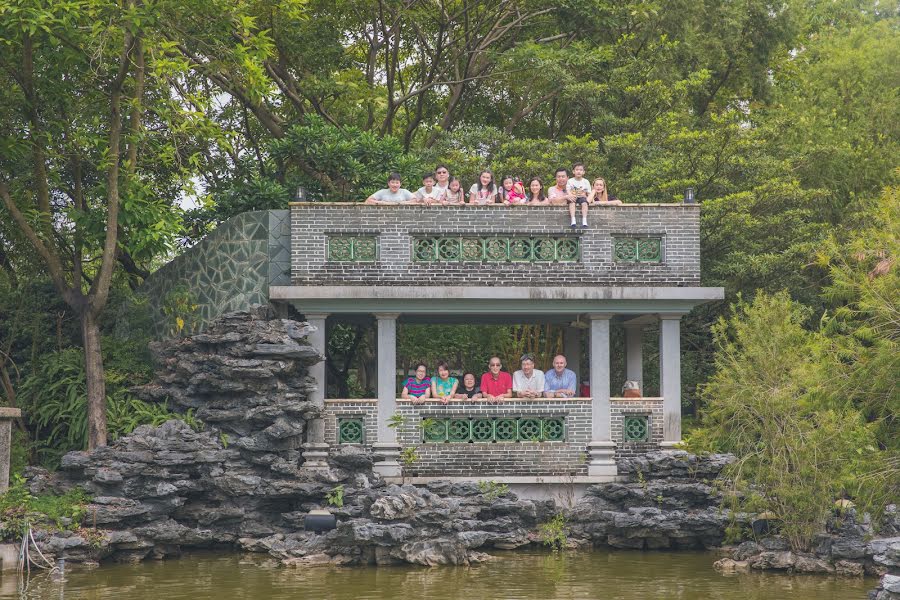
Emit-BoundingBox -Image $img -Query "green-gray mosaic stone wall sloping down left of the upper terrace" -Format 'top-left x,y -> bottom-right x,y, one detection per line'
140,210 -> 291,338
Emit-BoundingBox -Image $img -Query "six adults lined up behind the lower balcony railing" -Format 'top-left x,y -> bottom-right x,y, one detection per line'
400,354 -> 590,404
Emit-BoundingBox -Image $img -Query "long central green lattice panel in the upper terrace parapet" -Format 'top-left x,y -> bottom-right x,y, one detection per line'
412,236 -> 581,263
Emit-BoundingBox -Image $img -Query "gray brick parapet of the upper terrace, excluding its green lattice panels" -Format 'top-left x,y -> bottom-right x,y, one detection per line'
291,203 -> 700,287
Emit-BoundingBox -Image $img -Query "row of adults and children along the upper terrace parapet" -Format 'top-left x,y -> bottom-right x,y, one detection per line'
366,163 -> 622,229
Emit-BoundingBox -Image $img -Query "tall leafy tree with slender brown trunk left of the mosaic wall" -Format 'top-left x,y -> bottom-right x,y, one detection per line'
0,0 -> 200,448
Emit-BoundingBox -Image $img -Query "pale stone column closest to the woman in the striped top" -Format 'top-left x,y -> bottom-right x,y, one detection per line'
373,313 -> 401,477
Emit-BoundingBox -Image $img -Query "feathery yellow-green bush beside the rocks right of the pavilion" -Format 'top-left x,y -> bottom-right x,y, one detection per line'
688,293 -> 882,549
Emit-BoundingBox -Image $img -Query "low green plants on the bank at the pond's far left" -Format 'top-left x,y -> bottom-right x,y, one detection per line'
0,475 -> 90,539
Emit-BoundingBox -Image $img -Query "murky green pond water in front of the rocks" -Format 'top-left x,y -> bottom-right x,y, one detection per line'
0,550 -> 877,600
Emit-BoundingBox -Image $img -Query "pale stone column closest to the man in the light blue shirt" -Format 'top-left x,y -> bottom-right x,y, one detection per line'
588,313 -> 617,476
